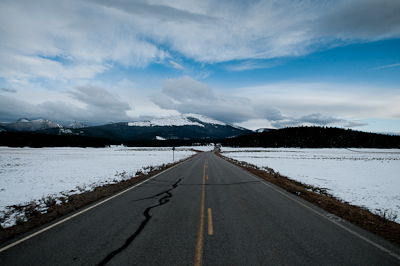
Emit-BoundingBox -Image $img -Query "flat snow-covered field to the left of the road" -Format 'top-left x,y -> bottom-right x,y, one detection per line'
0,146 -> 213,227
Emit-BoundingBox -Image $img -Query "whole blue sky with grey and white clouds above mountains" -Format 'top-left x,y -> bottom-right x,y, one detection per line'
0,0 -> 400,132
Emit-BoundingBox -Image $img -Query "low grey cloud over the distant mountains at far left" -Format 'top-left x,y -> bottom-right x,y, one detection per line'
0,85 -> 132,125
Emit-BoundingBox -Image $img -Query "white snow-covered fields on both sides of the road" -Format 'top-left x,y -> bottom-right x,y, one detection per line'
0,146 -> 400,226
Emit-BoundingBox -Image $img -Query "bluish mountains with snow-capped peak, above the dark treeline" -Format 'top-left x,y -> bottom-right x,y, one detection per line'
0,114 -> 253,142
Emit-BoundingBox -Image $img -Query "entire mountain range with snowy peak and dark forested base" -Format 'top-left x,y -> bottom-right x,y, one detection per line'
0,114 -> 400,149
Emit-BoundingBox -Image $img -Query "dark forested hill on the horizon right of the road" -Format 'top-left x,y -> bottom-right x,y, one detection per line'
221,127 -> 400,148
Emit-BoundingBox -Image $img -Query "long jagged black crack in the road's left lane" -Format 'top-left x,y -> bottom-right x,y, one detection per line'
98,178 -> 182,266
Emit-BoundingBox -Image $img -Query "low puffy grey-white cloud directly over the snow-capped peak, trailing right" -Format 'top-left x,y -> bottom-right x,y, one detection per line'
153,76 -> 361,128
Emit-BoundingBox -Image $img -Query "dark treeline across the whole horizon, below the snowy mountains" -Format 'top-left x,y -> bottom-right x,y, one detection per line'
0,127 -> 400,148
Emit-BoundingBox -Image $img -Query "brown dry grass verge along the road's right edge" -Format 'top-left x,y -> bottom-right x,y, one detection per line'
217,154 -> 400,245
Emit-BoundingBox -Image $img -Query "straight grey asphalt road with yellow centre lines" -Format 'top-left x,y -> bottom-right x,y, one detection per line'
0,152 -> 400,266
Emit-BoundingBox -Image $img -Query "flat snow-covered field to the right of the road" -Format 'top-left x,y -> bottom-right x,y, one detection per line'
221,147 -> 400,223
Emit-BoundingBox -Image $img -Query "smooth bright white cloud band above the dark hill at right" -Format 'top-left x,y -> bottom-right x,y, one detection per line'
232,83 -> 400,119
